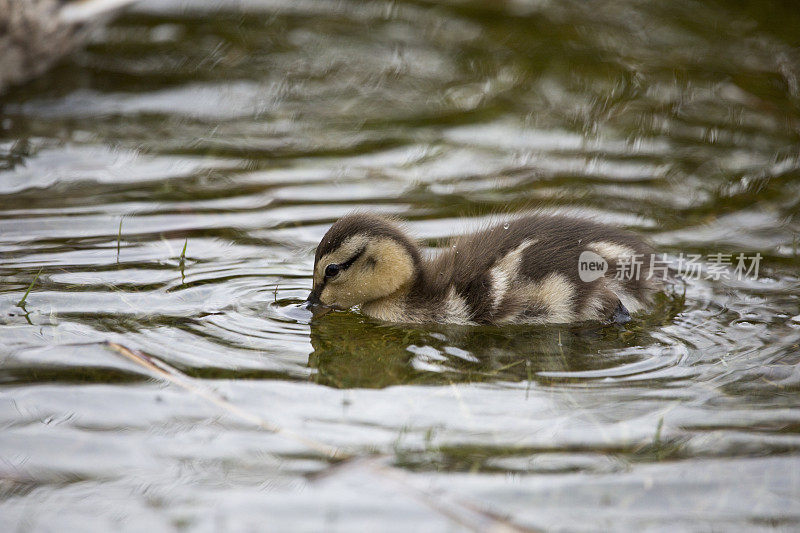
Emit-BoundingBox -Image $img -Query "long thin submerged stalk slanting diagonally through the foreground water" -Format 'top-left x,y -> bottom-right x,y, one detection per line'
104,341 -> 536,533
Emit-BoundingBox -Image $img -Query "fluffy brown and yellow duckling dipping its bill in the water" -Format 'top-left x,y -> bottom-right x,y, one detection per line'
306,213 -> 659,325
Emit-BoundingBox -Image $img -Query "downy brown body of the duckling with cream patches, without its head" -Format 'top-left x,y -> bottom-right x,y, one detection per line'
420,215 -> 659,324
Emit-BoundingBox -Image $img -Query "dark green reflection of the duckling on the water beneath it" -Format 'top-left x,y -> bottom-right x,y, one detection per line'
309,295 -> 682,389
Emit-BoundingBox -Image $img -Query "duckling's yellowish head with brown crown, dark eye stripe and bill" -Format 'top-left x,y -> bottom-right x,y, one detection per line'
306,213 -> 421,314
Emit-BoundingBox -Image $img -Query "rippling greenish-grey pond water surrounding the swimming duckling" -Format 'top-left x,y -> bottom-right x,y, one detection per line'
0,0 -> 800,532
